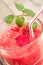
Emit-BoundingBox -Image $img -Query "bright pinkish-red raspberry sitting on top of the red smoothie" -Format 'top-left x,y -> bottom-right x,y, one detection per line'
16,34 -> 30,46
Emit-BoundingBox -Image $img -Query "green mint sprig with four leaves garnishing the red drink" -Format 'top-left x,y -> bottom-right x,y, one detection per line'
4,3 -> 35,28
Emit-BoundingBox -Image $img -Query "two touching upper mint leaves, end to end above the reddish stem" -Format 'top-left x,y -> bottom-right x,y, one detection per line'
15,3 -> 35,17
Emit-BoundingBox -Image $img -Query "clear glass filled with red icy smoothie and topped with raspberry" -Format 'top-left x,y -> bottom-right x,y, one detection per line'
0,16 -> 43,65
